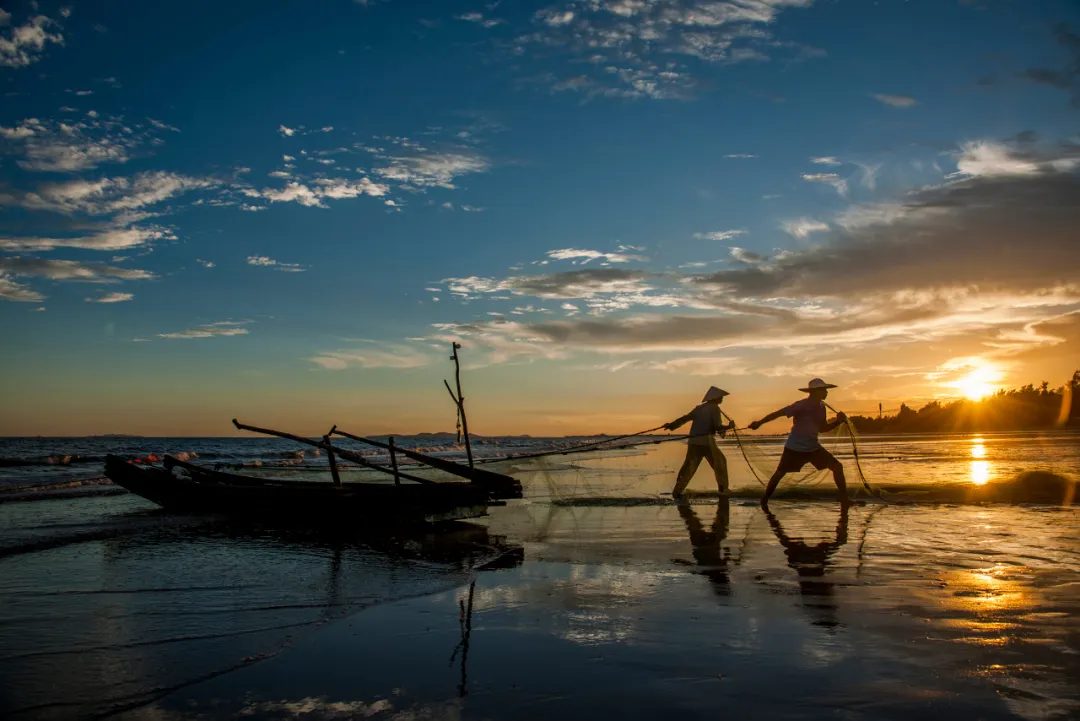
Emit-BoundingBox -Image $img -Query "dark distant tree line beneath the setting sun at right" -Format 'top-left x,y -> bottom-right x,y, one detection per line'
850,370 -> 1080,433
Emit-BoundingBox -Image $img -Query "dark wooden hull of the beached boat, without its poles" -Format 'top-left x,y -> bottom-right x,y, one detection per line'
105,455 -> 503,526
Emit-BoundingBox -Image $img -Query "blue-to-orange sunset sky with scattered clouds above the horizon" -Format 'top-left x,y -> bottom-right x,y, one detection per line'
0,0 -> 1080,436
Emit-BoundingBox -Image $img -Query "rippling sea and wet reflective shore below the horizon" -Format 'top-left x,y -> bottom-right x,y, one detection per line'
0,431 -> 1080,721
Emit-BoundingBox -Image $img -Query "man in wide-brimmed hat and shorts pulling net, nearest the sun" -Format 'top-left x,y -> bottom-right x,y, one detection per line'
750,378 -> 851,508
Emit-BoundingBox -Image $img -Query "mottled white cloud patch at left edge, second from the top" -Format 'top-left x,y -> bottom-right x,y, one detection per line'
0,115 -> 170,173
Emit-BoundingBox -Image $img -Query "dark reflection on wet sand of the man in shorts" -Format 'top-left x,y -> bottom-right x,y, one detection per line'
765,506 -> 848,628
